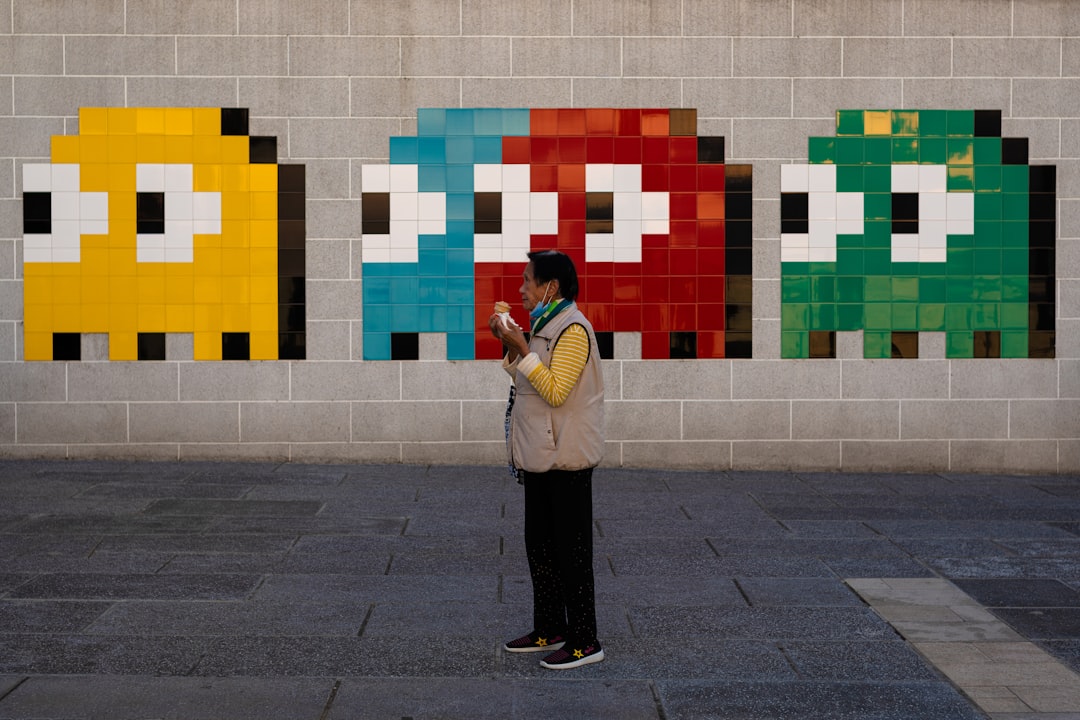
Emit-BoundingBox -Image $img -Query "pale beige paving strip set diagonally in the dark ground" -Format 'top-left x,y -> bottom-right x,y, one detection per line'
845,578 -> 1080,720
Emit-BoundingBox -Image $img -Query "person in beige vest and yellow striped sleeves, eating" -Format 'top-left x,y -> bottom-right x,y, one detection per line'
488,250 -> 604,669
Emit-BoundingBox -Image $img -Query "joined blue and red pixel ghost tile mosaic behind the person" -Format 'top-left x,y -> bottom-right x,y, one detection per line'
362,108 -> 753,361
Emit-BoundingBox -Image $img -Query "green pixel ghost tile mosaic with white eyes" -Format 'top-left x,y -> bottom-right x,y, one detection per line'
781,110 -> 1057,358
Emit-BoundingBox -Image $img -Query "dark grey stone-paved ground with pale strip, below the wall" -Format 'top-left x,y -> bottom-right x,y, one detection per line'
0,461 -> 1080,720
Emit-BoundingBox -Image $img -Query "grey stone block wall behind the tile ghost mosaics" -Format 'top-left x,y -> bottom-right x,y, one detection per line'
0,0 -> 1080,473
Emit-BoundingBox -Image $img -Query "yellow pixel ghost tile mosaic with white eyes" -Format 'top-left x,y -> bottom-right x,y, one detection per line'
23,108 -> 306,361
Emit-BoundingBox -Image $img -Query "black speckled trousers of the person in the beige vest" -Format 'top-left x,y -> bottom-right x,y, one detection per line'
525,467 -> 596,647
